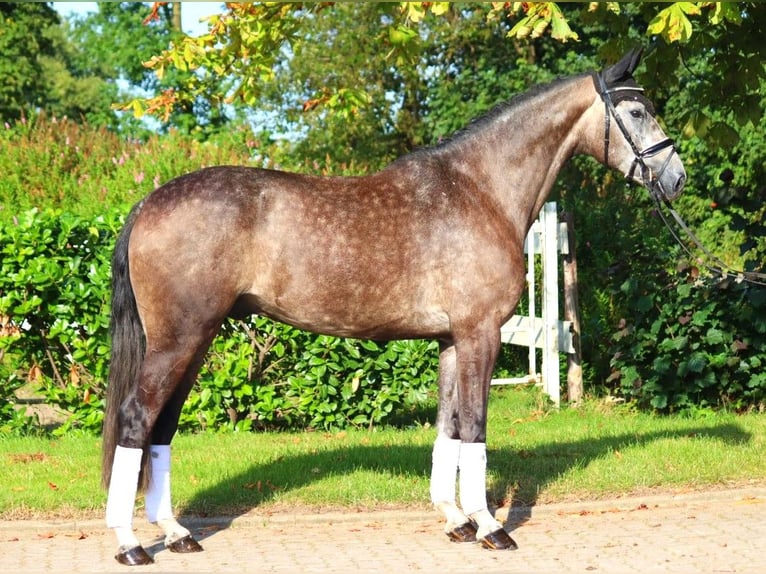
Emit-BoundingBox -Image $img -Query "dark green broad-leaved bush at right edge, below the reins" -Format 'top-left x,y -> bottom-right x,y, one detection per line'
611,268 -> 766,412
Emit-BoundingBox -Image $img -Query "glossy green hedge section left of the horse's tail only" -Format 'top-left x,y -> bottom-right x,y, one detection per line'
0,211 -> 120,434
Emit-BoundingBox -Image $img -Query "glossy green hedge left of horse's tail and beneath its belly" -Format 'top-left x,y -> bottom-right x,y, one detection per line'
0,211 -> 438,431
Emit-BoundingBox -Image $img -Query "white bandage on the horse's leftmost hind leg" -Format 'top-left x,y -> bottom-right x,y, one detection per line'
106,446 -> 143,547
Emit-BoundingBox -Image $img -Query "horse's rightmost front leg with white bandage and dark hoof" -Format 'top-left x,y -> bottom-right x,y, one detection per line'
455,325 -> 517,550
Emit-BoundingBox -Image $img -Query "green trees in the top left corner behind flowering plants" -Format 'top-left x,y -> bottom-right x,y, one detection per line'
0,2 -> 210,137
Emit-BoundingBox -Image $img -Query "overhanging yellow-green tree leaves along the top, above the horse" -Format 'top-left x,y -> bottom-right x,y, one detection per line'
131,2 -> 766,132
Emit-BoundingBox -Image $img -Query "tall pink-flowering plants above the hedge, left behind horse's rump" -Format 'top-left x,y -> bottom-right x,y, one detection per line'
0,115 -> 254,222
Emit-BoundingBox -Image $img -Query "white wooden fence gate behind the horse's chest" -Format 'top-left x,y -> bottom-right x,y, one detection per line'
492,202 -> 574,406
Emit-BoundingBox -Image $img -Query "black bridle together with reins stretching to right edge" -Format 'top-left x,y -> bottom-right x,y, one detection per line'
594,74 -> 766,285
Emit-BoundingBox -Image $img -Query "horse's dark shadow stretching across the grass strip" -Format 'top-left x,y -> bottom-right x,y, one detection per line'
172,423 -> 751,552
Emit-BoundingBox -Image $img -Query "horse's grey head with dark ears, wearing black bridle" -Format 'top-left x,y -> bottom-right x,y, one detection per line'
594,50 -> 686,204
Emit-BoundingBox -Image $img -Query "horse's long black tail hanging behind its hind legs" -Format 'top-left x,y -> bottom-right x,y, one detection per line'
101,203 -> 148,488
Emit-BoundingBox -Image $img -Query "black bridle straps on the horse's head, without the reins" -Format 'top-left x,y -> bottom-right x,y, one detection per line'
595,74 -> 676,199
